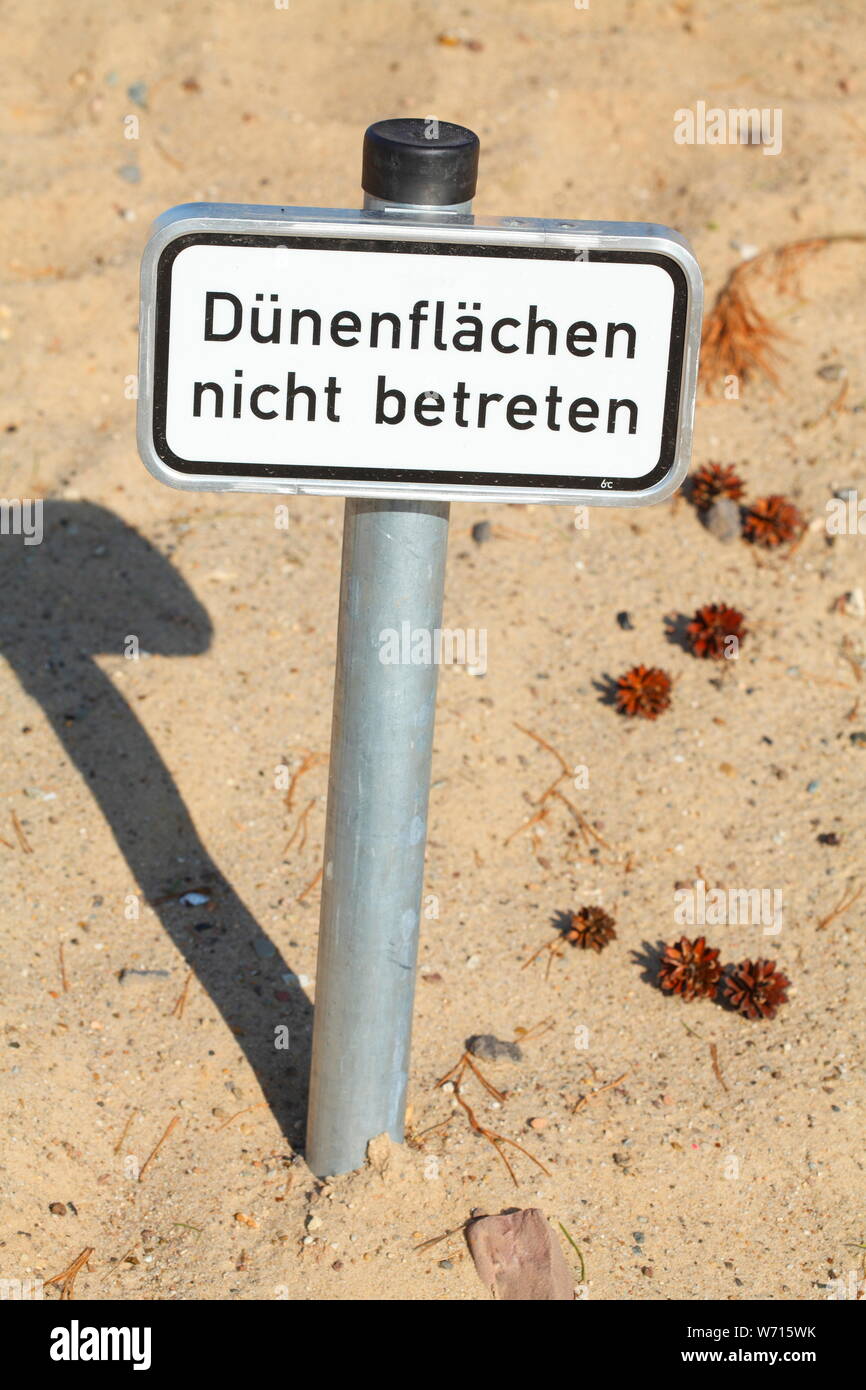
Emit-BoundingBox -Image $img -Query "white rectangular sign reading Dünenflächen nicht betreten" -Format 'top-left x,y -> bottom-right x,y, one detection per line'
139,204 -> 702,506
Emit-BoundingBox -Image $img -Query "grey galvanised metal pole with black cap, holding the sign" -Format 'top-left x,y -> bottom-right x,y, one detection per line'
306,120 -> 478,1176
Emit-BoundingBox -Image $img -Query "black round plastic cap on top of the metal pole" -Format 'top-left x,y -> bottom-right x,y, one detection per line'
361,115 -> 478,207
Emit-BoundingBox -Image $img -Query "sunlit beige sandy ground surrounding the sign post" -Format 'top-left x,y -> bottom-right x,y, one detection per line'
0,0 -> 866,1300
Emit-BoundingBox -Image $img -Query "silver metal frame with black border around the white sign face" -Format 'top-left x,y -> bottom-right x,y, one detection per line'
138,203 -> 703,506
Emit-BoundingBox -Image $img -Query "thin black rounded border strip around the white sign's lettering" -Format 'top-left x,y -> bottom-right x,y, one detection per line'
152,232 -> 688,492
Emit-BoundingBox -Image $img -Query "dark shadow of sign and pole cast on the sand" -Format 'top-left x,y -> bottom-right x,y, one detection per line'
0,500 -> 313,1148
